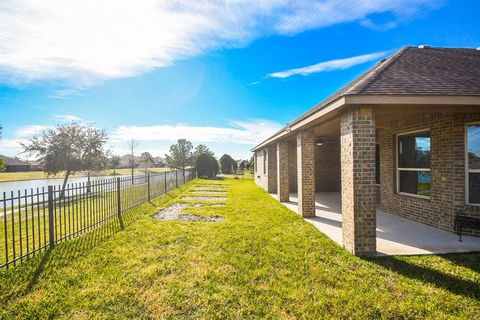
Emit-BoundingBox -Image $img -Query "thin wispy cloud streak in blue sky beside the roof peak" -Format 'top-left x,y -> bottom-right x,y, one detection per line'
267,51 -> 389,78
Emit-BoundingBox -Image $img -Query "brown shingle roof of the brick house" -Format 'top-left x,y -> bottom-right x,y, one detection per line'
253,47 -> 480,151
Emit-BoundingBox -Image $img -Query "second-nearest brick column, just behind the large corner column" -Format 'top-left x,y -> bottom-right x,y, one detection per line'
297,129 -> 315,217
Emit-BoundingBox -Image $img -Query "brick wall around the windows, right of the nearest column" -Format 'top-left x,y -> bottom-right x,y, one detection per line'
379,113 -> 480,235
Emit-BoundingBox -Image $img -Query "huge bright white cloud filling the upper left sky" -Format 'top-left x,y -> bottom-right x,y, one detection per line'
0,0 -> 436,85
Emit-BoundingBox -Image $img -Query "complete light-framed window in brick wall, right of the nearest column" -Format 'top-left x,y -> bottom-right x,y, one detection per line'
397,131 -> 432,198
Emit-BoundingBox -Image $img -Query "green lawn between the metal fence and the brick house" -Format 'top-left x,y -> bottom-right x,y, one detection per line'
0,179 -> 480,319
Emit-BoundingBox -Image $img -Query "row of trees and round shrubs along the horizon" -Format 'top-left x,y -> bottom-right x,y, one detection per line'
9,121 -> 253,194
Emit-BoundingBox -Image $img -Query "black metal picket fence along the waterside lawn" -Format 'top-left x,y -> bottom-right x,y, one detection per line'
0,169 -> 195,268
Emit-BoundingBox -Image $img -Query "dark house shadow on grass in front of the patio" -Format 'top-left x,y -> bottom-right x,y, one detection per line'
366,253 -> 480,299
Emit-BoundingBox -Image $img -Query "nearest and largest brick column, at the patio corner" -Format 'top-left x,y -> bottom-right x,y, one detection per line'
340,107 -> 377,255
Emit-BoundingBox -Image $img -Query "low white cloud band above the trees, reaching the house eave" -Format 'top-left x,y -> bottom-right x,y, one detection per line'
111,120 -> 281,144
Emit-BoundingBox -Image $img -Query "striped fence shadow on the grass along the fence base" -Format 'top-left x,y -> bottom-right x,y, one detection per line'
0,203 -> 154,305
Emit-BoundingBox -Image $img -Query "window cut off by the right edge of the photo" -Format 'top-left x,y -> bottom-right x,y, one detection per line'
465,124 -> 480,204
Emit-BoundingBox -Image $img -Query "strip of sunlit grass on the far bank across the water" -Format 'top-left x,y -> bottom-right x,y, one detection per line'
0,168 -> 171,182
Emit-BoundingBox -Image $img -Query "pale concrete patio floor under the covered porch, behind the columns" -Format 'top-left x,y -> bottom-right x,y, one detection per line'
272,192 -> 480,255
